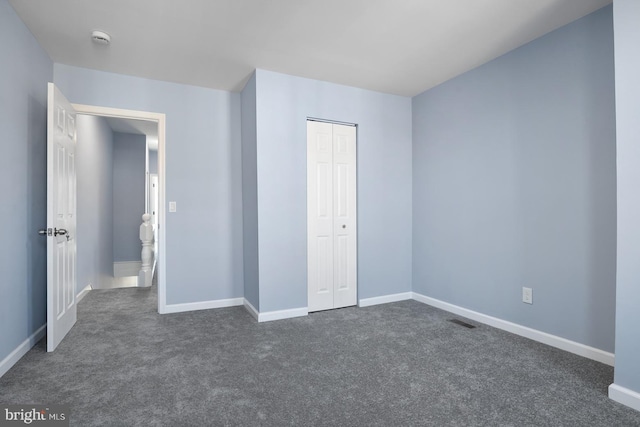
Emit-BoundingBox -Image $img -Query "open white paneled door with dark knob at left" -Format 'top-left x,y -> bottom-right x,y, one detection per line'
47,83 -> 76,351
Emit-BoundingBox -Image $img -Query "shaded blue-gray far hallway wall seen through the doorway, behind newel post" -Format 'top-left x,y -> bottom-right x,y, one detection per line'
113,132 -> 147,262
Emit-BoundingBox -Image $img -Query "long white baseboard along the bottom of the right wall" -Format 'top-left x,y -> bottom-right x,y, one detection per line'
413,292 -> 615,366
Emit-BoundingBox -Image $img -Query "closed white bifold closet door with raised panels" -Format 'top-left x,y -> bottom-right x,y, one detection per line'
307,121 -> 357,311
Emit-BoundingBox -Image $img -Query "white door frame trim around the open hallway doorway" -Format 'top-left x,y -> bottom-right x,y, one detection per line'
71,104 -> 167,314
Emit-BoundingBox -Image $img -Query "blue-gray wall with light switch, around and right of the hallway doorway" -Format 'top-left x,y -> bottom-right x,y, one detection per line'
54,64 -> 243,304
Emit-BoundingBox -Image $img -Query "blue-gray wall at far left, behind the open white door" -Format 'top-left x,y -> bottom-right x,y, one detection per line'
0,0 -> 53,361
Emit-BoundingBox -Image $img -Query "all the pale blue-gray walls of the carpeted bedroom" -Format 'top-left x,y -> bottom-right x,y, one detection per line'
0,0 -> 640,391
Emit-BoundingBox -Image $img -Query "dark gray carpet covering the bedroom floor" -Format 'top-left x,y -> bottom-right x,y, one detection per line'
0,287 -> 640,426
